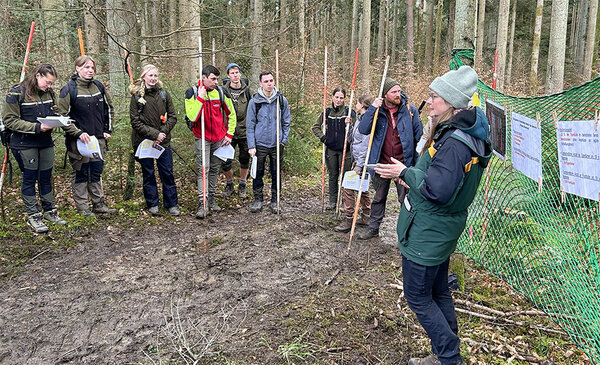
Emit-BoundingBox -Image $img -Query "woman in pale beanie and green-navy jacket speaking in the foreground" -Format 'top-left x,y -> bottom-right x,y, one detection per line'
375,66 -> 492,365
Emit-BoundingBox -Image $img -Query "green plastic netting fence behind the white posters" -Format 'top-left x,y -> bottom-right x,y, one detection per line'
451,50 -> 600,364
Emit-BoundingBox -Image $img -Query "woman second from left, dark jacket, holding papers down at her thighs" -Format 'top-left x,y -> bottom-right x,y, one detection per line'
57,55 -> 116,216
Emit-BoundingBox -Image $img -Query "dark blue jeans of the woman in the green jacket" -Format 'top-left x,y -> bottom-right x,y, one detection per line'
402,255 -> 462,365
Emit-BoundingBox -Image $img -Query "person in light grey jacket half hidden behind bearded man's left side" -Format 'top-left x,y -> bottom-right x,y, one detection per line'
333,95 -> 373,233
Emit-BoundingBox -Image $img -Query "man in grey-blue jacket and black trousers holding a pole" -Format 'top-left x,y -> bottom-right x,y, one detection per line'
246,71 -> 291,213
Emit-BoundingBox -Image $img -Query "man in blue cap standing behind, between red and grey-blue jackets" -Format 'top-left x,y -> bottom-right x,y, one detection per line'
221,62 -> 252,199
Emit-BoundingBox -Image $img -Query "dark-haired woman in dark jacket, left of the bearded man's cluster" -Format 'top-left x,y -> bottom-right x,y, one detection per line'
312,87 -> 356,210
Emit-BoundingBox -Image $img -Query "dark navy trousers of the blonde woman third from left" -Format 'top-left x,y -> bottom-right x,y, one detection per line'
138,147 -> 177,209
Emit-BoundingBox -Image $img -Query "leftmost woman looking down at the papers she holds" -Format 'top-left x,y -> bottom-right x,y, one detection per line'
2,63 -> 89,233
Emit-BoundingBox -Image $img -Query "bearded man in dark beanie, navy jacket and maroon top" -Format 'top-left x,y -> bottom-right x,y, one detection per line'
358,78 -> 423,240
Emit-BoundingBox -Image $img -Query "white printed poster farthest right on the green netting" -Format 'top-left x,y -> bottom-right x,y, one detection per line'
556,120 -> 600,201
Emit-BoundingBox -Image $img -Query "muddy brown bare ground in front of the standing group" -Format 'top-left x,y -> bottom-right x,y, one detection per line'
0,192 -> 408,364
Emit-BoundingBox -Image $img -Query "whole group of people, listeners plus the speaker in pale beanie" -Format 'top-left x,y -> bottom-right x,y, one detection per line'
3,56 -> 491,365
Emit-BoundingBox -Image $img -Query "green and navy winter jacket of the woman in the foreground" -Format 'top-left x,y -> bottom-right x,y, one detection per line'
396,108 -> 492,266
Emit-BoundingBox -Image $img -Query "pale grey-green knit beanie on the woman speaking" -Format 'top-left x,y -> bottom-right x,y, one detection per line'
429,66 -> 477,109
